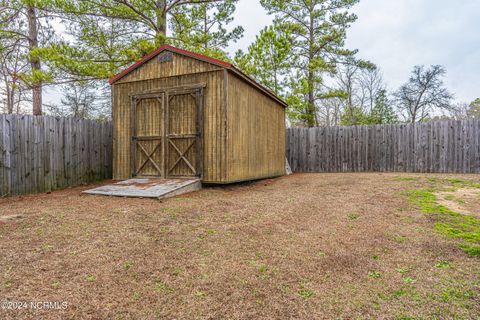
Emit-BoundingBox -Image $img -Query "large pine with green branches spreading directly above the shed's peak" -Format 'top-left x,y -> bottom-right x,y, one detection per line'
42,0 -> 243,82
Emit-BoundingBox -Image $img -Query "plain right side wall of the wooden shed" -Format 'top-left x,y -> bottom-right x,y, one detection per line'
226,72 -> 285,182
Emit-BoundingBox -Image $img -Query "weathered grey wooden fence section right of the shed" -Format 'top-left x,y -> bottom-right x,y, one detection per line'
286,120 -> 480,173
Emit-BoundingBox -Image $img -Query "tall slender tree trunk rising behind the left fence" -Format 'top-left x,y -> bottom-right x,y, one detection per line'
27,6 -> 42,116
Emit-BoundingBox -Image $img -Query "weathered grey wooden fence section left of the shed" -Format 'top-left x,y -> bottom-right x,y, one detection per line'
0,115 -> 112,196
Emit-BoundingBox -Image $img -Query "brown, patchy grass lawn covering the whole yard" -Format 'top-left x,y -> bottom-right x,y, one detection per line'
0,173 -> 480,319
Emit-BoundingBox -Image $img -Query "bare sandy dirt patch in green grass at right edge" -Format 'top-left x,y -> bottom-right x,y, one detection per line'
435,188 -> 480,217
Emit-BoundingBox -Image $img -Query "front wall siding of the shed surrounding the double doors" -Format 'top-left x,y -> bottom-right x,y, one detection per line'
112,70 -> 226,183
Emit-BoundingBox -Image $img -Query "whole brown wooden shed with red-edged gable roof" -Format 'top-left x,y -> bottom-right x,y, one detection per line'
110,45 -> 286,184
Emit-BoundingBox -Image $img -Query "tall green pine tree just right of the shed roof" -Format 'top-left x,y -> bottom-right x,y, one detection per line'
261,0 -> 366,126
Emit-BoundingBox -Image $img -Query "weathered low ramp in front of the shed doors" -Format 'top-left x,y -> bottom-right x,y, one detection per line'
83,179 -> 202,199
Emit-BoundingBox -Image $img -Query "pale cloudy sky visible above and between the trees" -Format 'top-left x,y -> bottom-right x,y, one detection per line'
45,0 -> 480,102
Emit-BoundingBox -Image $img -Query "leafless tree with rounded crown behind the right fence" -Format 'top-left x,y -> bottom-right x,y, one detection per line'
394,65 -> 453,123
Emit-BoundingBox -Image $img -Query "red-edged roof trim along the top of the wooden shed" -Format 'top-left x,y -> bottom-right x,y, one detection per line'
108,44 -> 287,107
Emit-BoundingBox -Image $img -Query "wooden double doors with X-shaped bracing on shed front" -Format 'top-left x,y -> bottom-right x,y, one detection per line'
131,85 -> 204,178
